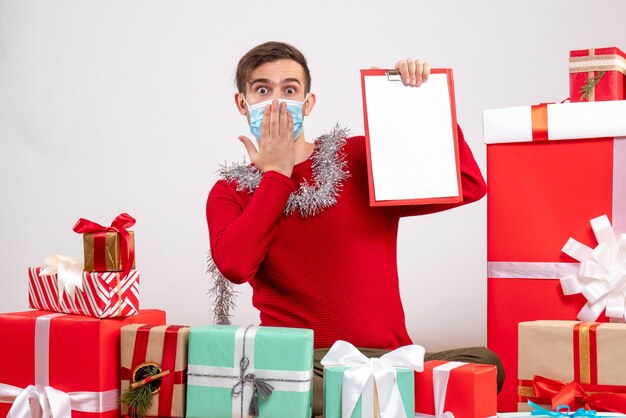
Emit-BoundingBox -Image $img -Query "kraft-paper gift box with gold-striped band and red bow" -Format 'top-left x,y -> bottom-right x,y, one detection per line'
518,321 -> 626,413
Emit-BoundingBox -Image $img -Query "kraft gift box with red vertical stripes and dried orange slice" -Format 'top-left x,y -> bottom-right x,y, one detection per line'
121,324 -> 190,417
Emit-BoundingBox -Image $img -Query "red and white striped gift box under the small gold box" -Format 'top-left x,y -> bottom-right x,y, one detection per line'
28,267 -> 139,318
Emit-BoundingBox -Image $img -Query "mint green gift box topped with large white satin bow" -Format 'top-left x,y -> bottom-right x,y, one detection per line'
321,340 -> 424,418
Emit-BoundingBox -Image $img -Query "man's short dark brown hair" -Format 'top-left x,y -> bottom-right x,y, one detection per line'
235,41 -> 311,94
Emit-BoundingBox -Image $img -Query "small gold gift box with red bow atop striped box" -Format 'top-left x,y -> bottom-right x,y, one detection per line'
73,213 -> 135,272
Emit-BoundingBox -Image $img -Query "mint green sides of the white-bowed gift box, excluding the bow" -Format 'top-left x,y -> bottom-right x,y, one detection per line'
324,366 -> 415,418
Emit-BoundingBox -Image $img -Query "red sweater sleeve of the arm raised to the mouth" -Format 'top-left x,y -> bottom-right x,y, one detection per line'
206,171 -> 296,284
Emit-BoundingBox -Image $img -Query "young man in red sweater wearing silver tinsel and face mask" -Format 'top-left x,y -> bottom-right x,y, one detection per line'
206,42 -> 504,415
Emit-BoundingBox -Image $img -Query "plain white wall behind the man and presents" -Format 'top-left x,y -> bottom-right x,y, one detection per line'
0,0 -> 626,351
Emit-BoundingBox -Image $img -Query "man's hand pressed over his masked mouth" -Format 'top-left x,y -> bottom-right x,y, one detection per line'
239,99 -> 295,177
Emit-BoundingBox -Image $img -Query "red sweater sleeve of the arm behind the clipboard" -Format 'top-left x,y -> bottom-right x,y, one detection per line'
399,125 -> 487,216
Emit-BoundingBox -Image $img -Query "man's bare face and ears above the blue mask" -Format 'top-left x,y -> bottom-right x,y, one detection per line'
235,59 -> 315,116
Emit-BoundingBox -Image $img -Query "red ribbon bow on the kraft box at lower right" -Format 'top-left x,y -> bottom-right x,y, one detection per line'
533,376 -> 626,414
